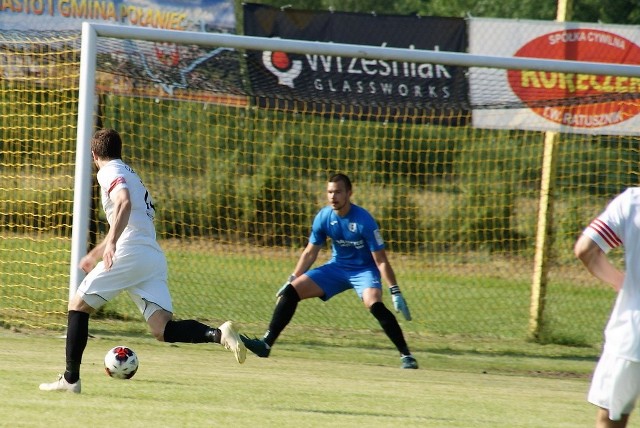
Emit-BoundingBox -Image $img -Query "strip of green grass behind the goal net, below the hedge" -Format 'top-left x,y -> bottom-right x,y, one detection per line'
0,234 -> 614,350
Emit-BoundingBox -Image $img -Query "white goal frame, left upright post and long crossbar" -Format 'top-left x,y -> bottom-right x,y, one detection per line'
69,22 -> 640,298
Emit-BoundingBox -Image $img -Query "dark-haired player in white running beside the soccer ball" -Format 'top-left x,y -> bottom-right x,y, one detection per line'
40,129 -> 247,393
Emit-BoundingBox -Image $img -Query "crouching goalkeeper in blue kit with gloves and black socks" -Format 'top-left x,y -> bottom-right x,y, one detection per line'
240,174 -> 418,369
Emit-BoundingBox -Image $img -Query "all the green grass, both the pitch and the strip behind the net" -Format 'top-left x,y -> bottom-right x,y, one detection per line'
0,232 -> 612,428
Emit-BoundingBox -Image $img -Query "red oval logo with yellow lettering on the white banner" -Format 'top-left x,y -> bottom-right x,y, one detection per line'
507,28 -> 640,128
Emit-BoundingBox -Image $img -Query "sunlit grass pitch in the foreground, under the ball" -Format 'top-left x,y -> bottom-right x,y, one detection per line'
0,322 -> 600,428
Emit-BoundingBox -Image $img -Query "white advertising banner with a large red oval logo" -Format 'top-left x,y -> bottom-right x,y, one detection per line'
469,18 -> 640,134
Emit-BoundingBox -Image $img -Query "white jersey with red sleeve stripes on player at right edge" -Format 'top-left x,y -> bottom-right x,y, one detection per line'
583,187 -> 640,361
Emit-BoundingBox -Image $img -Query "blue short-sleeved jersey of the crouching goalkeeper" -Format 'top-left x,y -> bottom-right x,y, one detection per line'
309,204 -> 384,268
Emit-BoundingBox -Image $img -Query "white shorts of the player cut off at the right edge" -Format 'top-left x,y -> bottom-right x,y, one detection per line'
587,353 -> 640,421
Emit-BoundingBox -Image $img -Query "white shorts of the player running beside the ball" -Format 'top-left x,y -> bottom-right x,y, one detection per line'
78,247 -> 173,320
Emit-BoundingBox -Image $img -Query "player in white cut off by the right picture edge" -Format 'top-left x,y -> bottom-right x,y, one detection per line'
574,187 -> 640,428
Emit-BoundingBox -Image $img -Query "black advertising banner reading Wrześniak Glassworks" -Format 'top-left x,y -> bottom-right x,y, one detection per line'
243,4 -> 468,123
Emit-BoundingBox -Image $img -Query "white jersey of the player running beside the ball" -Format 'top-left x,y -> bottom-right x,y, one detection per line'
97,159 -> 160,250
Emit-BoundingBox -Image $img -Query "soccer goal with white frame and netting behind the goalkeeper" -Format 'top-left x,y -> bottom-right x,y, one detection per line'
0,24 -> 640,342
